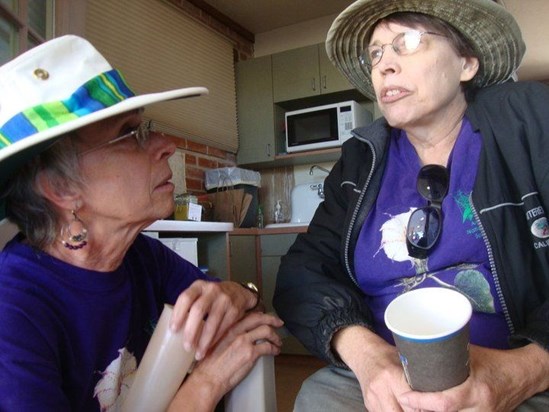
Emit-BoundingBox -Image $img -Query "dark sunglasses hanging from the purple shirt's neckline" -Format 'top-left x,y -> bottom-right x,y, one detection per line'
406,165 -> 449,259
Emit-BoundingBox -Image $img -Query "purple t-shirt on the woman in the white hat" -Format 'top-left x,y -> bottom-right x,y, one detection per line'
0,235 -> 210,412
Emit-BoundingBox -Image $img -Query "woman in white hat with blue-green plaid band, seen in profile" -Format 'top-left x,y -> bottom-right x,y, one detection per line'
0,36 -> 282,412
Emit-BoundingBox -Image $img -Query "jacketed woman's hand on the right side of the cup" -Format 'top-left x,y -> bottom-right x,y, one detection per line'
399,344 -> 549,412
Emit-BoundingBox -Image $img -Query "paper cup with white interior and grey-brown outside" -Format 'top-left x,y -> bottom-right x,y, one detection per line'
385,287 -> 473,392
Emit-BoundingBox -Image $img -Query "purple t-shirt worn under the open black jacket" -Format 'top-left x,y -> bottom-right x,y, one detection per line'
355,119 -> 509,349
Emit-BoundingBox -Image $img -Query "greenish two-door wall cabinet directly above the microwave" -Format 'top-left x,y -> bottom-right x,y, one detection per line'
272,43 -> 353,103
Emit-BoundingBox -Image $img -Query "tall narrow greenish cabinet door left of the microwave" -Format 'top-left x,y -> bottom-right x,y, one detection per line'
236,56 -> 275,164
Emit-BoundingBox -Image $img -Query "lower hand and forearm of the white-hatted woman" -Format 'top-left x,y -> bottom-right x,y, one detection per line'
170,312 -> 283,412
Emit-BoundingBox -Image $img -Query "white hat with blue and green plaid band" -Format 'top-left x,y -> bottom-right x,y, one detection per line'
0,35 -> 208,220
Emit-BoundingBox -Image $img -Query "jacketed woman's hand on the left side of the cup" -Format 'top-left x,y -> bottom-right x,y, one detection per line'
332,326 -> 410,412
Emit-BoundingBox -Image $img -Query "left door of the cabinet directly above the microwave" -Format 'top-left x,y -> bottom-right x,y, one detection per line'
272,44 -> 320,103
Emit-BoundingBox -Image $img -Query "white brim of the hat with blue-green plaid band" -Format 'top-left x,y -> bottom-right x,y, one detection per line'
0,87 -> 208,221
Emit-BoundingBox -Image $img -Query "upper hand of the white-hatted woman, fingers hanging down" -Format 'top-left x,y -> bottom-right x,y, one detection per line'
170,280 -> 257,360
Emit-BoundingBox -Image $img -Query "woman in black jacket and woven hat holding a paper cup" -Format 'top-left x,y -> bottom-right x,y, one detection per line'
274,0 -> 549,411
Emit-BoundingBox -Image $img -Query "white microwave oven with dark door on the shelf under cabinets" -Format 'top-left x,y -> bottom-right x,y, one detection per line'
285,100 -> 372,153
